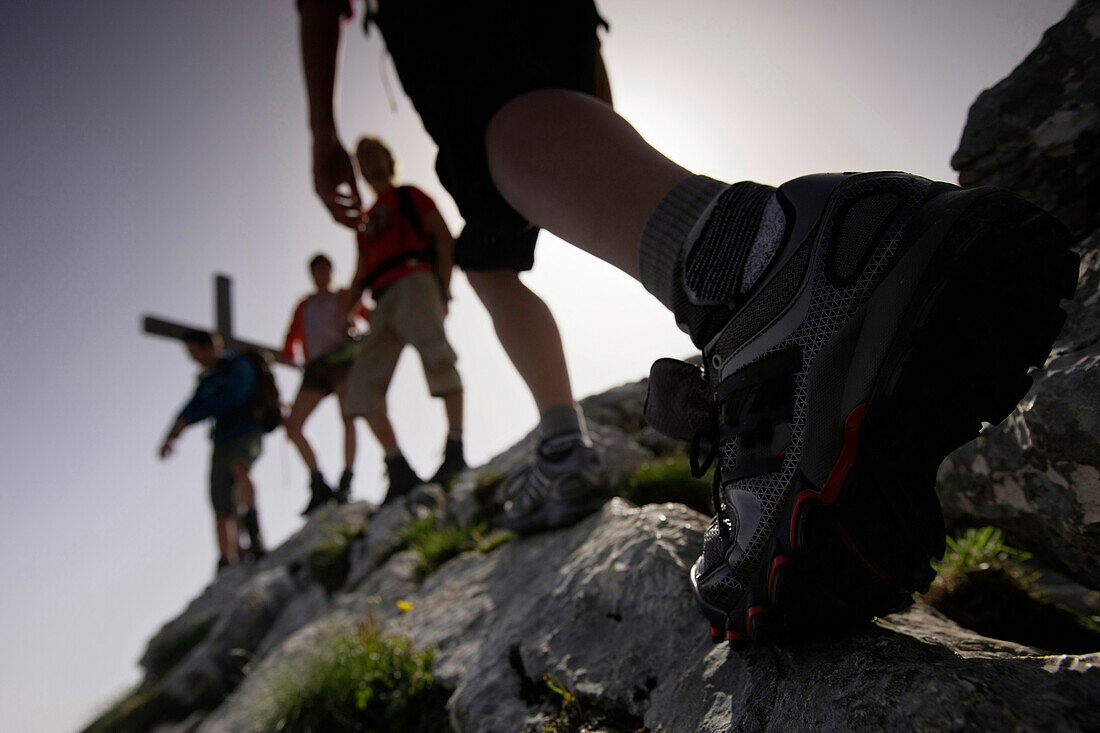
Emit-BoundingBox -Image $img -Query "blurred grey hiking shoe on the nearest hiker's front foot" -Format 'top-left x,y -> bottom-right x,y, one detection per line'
504,433 -> 611,535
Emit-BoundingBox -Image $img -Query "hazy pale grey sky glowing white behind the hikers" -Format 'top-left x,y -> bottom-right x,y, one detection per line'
0,0 -> 1071,731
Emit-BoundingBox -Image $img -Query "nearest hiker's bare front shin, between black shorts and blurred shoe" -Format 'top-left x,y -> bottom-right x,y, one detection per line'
466,270 -> 576,413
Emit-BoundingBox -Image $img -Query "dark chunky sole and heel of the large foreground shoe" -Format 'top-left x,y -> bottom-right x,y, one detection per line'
691,188 -> 1078,645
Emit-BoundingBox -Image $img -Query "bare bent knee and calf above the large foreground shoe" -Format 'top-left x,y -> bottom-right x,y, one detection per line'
485,89 -> 691,277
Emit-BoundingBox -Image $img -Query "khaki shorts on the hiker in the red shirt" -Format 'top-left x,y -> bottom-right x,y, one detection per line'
343,272 -> 462,417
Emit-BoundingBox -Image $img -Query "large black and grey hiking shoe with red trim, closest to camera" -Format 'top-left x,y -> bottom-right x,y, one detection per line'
646,173 -> 1078,644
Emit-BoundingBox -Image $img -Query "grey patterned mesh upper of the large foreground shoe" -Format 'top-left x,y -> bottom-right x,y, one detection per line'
697,174 -> 931,606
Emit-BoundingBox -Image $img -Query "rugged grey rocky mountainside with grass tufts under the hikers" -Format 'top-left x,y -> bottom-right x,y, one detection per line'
88,5 -> 1100,733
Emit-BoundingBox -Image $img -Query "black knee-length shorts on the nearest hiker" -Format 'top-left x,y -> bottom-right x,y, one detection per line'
373,0 -> 606,271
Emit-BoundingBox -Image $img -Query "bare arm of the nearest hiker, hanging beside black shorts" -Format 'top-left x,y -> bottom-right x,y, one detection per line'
298,0 -> 362,229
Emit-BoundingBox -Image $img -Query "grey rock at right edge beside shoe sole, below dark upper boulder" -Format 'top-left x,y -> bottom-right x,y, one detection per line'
937,236 -> 1100,588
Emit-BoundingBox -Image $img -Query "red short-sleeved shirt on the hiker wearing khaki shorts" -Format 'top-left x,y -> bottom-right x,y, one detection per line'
356,186 -> 436,293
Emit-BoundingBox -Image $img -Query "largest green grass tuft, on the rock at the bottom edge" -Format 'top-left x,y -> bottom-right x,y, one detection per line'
252,621 -> 451,733
